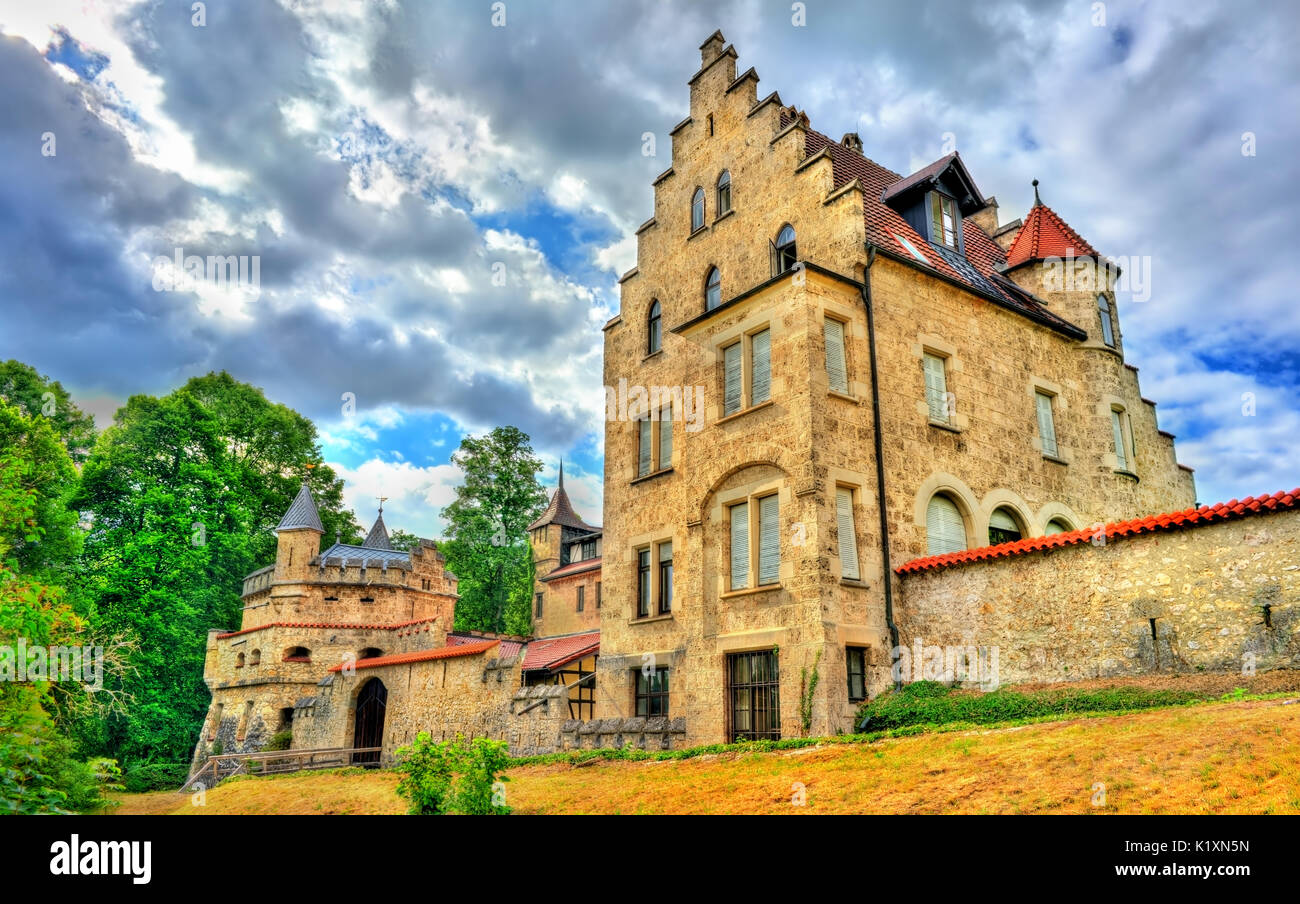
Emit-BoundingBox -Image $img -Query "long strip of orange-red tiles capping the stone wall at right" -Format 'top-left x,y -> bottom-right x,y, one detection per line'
894,486 -> 1300,575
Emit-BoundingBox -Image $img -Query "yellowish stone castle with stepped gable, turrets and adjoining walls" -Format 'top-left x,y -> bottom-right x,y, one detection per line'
195,33 -> 1300,761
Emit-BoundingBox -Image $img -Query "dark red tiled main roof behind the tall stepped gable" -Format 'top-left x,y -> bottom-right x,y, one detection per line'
781,122 -> 1091,339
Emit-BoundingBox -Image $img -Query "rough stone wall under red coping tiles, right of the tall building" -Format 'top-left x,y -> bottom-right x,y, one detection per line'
898,510 -> 1300,684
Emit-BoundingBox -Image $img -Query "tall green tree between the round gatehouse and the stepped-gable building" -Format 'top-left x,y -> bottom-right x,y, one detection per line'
439,427 -> 546,633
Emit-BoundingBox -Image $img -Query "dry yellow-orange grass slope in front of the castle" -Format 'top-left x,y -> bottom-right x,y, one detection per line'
104,700 -> 1300,814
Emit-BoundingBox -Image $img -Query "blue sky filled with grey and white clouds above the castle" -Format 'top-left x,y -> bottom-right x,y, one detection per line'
0,0 -> 1300,537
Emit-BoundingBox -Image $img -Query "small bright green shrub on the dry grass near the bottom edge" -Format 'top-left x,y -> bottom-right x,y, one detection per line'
397,732 -> 510,816
